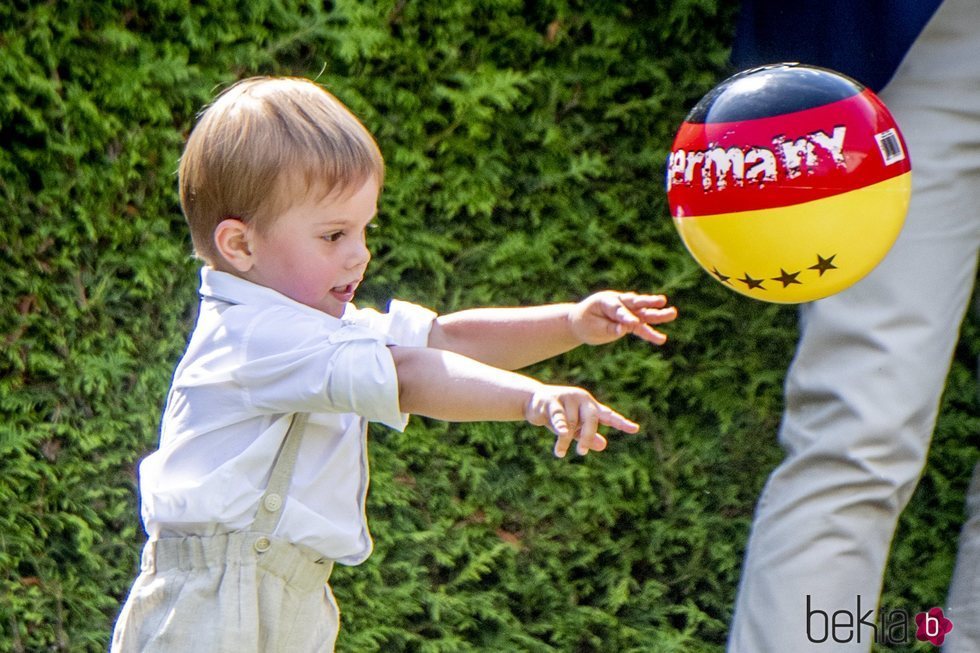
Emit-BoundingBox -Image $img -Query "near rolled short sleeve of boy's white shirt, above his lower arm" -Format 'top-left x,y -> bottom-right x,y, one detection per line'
235,309 -> 408,431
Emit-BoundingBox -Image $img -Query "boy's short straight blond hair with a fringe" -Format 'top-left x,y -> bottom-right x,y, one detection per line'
179,77 -> 384,265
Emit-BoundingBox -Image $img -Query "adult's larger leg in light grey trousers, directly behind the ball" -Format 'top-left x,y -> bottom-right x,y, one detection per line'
729,0 -> 980,653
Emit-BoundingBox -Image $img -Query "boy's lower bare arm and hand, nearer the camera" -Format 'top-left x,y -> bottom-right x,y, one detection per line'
390,347 -> 639,458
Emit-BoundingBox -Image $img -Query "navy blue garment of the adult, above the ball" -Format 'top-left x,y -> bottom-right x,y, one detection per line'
732,0 -> 942,91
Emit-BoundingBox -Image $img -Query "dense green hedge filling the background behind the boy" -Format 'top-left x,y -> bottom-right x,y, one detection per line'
0,0 -> 980,653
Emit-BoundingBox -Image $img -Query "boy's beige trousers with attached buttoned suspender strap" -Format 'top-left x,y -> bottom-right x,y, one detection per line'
110,413 -> 340,653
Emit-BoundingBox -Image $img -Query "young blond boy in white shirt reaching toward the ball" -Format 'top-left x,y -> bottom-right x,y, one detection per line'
112,78 -> 676,653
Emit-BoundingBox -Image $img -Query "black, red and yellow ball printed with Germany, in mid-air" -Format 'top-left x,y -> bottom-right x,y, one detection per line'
666,63 -> 912,304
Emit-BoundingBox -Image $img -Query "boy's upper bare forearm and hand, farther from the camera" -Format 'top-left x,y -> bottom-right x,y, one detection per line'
429,290 -> 677,370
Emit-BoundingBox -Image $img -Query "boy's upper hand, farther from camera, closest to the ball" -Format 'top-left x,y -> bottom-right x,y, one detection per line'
568,290 -> 677,345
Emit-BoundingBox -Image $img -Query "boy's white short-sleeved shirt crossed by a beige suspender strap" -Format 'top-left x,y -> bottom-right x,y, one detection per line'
140,267 -> 436,564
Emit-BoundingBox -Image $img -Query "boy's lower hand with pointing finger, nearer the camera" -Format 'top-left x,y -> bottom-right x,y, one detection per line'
524,385 -> 640,458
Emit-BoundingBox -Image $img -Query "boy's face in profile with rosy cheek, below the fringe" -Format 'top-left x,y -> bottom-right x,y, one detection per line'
242,179 -> 380,317
